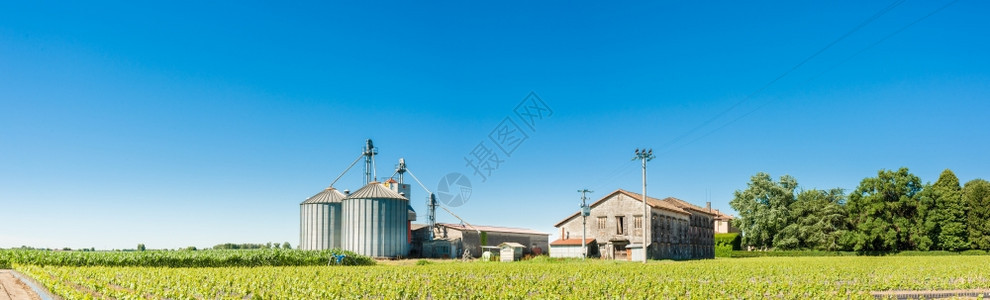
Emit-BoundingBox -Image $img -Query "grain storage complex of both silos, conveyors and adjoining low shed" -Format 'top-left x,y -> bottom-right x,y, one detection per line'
299,140 -> 549,258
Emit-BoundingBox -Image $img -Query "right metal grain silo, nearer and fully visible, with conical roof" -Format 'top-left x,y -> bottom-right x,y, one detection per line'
341,181 -> 409,257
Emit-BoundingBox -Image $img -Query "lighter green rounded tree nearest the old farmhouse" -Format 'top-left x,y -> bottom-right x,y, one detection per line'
729,172 -> 797,249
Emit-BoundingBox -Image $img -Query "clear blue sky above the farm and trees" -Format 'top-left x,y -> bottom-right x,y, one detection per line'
0,0 -> 990,249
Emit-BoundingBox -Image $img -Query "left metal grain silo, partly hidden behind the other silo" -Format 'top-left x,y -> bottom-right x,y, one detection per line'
298,187 -> 344,250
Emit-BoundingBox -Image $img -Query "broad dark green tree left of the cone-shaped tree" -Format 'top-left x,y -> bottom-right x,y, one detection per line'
845,168 -> 922,251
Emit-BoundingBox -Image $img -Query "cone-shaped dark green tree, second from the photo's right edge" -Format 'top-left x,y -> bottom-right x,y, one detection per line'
915,169 -> 969,251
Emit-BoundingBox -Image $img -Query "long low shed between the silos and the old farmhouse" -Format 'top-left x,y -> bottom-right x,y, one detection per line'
412,223 -> 550,258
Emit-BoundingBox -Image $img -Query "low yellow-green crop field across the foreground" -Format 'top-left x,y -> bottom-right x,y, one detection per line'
13,256 -> 990,299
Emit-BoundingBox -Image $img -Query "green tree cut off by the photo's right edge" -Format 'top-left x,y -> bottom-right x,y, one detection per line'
963,179 -> 990,250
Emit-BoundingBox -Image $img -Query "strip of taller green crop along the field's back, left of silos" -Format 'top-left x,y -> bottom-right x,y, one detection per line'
0,249 -> 375,268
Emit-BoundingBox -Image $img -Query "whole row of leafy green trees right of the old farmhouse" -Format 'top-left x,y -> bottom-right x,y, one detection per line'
729,168 -> 990,252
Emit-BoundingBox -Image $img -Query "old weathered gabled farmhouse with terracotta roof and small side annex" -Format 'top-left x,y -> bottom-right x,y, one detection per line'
550,189 -> 715,260
